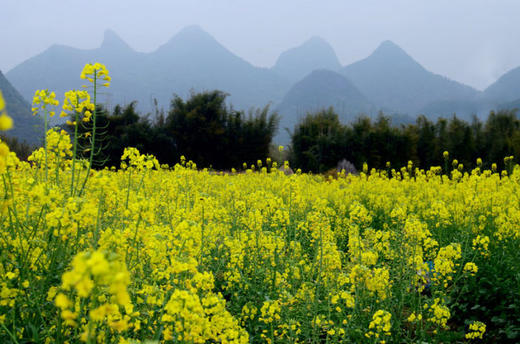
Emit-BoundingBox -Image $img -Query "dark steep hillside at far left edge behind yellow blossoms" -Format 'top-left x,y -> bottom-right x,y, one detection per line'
0,72 -> 43,144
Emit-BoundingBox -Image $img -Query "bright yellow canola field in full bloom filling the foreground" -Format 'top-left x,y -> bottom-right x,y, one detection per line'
4,64 -> 520,344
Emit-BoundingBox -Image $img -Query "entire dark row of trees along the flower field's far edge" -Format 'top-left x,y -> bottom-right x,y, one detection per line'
4,91 -> 520,173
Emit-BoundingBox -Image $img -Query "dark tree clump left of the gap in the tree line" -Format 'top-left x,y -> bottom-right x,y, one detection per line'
67,91 -> 279,170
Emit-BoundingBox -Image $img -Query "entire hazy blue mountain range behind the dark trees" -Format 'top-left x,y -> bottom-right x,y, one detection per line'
0,26 -> 520,143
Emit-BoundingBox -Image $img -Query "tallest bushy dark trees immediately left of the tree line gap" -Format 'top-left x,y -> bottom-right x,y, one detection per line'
166,91 -> 278,169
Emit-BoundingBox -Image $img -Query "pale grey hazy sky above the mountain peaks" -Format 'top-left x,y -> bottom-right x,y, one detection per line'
0,0 -> 520,89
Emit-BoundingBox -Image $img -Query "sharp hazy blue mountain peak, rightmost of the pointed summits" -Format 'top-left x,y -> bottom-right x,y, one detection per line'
341,41 -> 479,115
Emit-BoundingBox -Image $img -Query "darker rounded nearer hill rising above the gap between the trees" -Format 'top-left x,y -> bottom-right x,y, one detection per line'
275,69 -> 374,144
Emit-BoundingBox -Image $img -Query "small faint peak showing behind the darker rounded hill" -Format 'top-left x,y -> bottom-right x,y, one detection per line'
272,37 -> 341,83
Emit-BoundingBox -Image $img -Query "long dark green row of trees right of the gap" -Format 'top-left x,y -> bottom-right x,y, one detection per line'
291,108 -> 520,173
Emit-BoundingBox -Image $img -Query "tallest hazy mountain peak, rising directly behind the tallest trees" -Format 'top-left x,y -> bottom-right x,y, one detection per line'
148,26 -> 290,108
